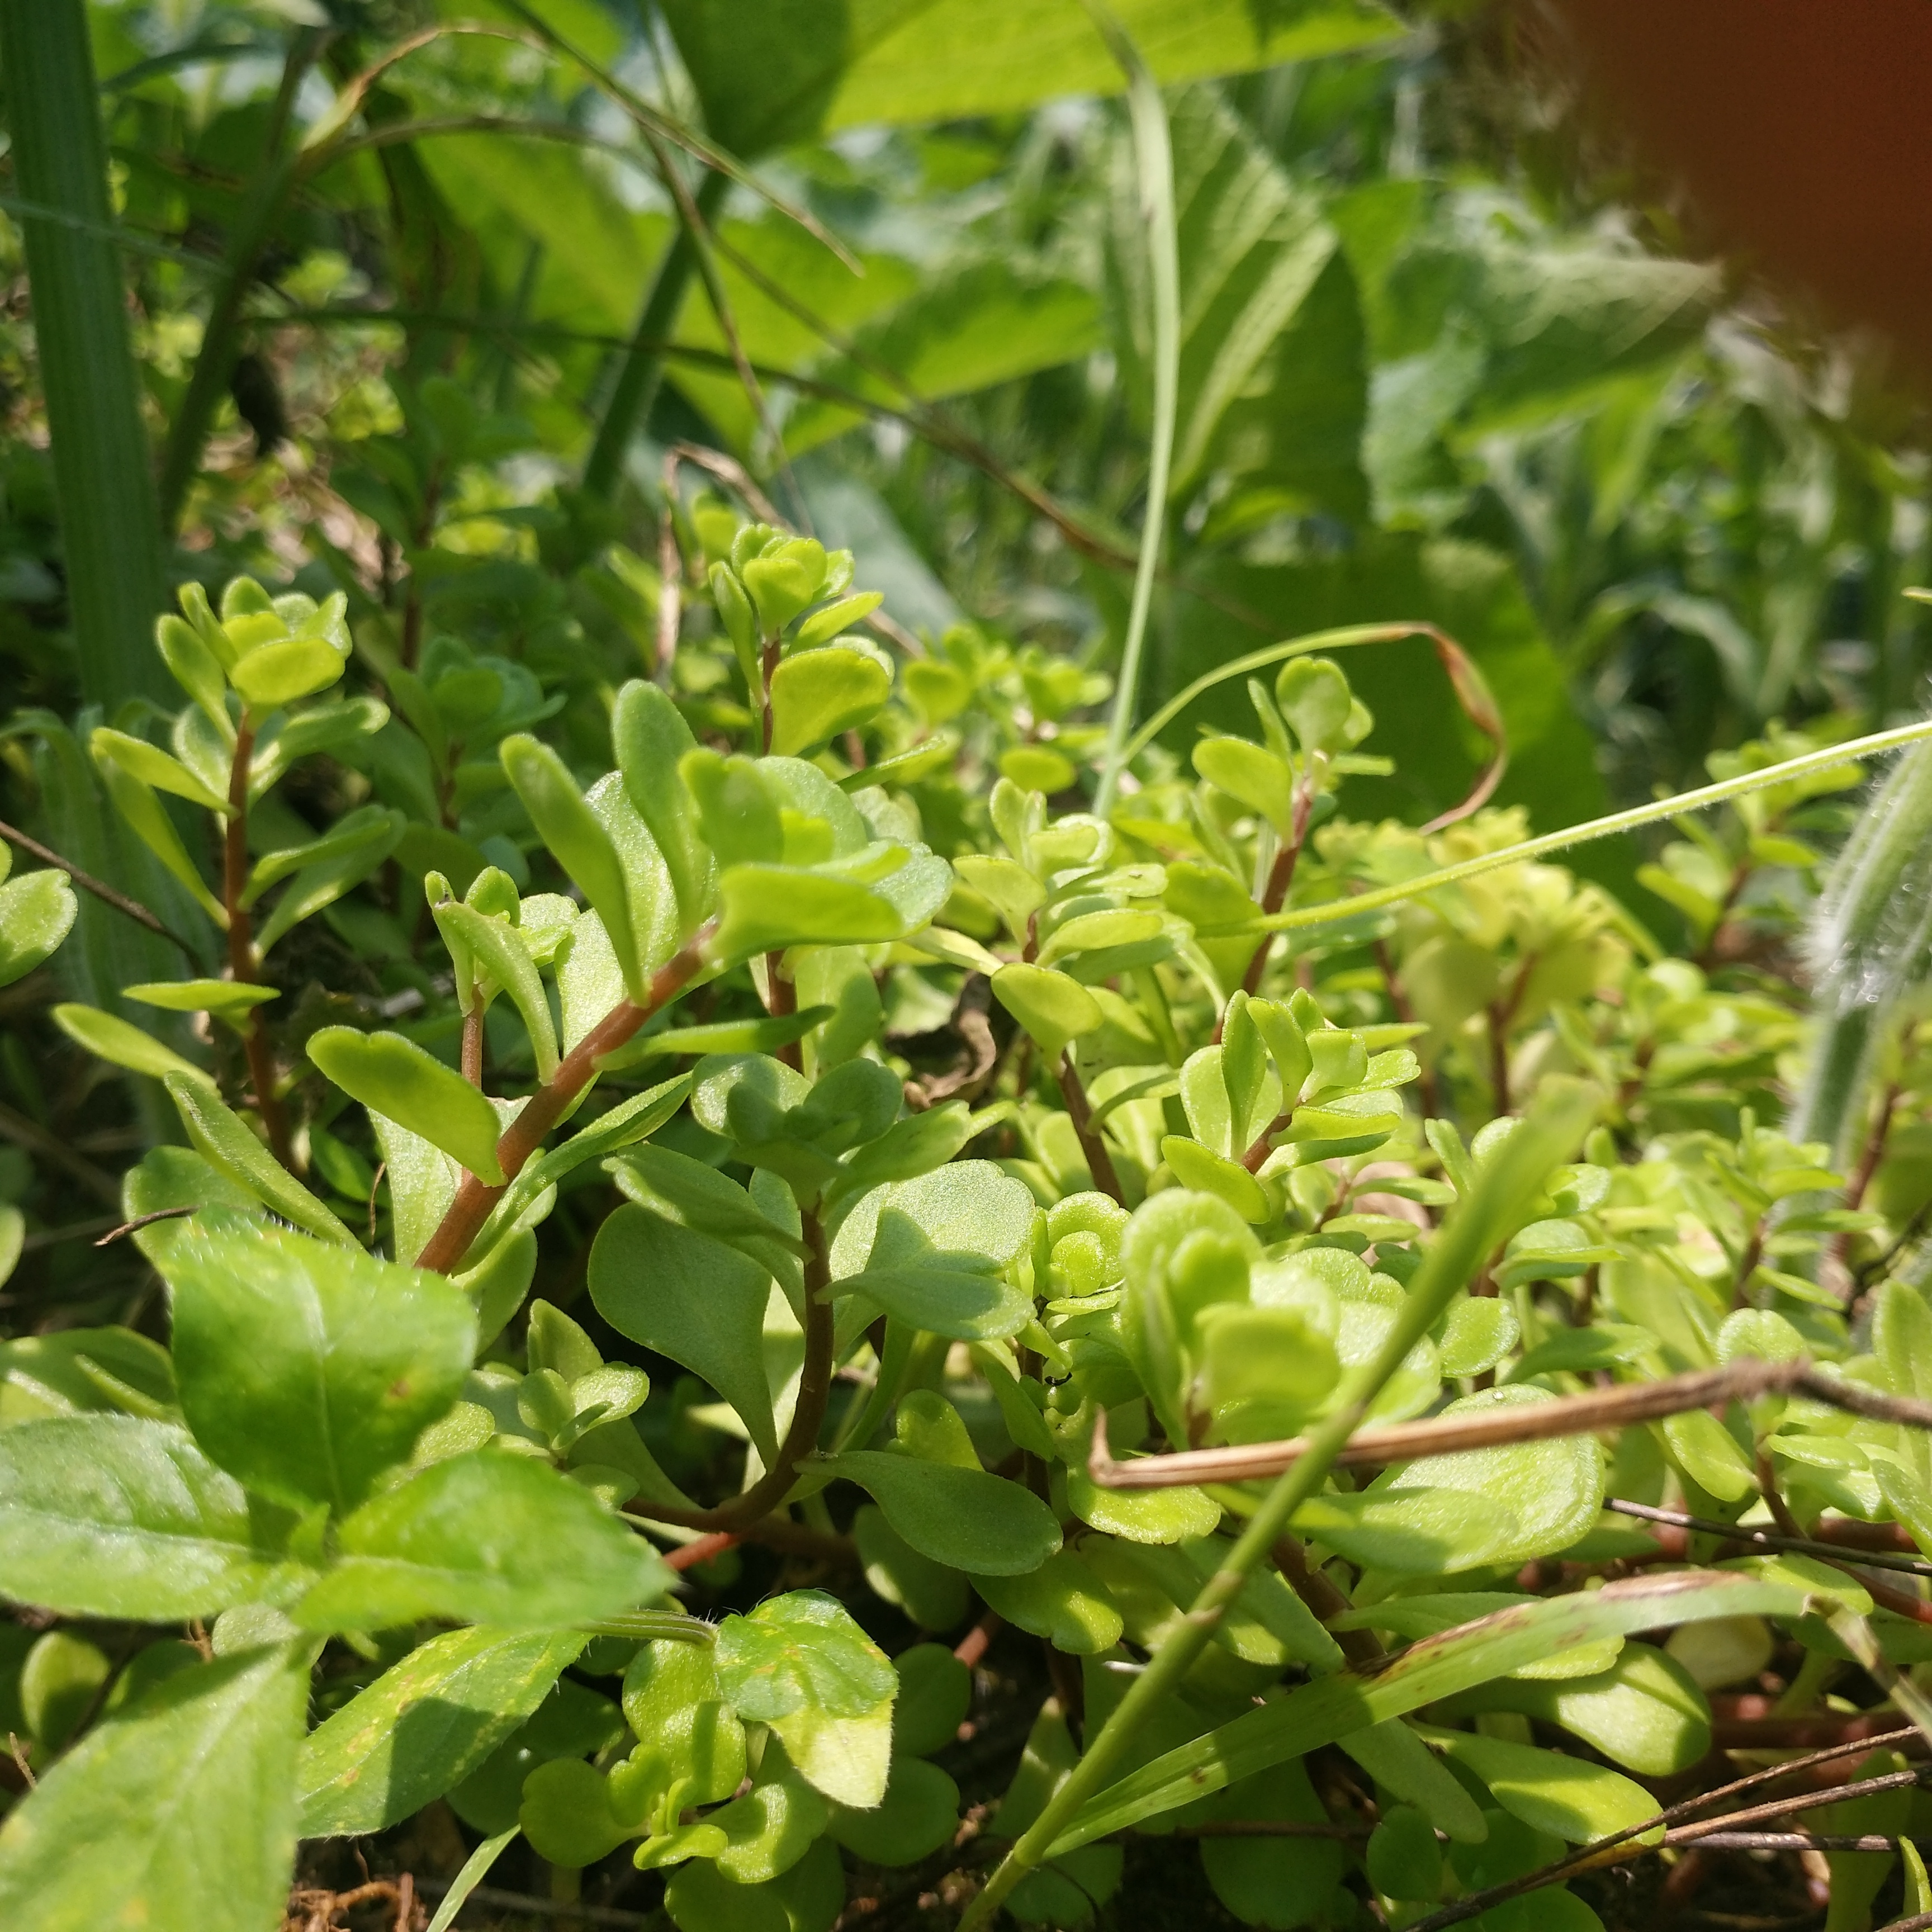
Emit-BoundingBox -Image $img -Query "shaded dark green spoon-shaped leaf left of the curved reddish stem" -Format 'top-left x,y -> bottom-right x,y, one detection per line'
589,1198 -> 779,1465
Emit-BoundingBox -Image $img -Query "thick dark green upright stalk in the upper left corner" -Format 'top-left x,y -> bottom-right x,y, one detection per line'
0,0 -> 179,711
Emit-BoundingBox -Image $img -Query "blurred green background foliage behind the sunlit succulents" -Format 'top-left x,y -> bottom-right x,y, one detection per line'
0,0 -> 1932,981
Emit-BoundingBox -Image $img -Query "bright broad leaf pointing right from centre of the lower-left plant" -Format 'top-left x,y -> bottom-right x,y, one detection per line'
292,1449 -> 673,1631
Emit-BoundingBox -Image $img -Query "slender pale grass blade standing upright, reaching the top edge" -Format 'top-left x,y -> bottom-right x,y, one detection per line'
1082,0 -> 1181,817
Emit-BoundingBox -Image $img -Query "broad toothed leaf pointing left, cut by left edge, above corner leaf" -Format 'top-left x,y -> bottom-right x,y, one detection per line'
0,1416 -> 291,1623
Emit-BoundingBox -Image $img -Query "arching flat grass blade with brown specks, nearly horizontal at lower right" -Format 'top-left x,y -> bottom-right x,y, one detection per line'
1049,1571 -> 1812,1857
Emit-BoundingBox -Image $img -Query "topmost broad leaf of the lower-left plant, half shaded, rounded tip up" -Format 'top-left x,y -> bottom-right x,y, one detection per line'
162,1217 -> 475,1511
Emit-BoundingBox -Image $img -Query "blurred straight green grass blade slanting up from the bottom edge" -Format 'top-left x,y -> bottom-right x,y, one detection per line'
960,1080 -> 1600,1932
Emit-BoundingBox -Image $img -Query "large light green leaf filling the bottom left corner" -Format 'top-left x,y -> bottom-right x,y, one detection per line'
0,1646 -> 309,1932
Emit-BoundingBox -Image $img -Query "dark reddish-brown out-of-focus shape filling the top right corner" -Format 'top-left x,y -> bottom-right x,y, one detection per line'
1543,0 -> 1932,382
